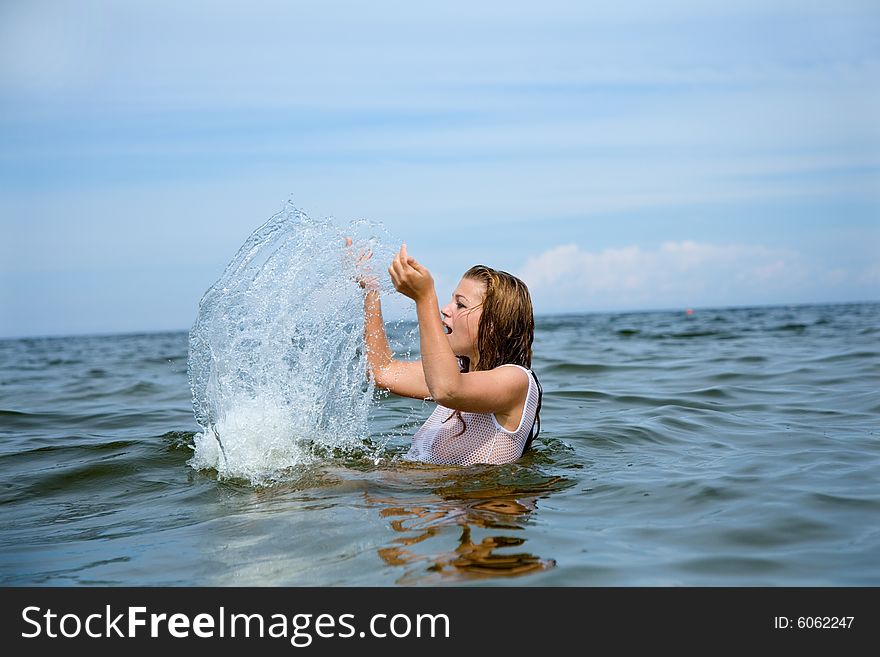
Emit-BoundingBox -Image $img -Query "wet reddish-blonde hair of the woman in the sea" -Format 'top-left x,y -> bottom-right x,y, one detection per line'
462,265 -> 535,372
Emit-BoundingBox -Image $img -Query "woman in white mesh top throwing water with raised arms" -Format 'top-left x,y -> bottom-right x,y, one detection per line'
361,244 -> 542,465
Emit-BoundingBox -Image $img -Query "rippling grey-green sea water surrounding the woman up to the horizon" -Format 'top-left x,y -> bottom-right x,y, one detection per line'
0,270 -> 880,586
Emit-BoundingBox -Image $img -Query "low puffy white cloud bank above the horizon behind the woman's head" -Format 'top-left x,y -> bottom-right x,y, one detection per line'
519,240 -> 824,311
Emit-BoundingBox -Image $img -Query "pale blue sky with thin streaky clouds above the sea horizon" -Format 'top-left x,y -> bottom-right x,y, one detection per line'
0,0 -> 880,336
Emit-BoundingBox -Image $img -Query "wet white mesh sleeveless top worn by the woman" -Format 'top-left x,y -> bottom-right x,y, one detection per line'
406,363 -> 538,465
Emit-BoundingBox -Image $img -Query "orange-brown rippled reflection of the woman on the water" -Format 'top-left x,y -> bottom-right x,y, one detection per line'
365,472 -> 570,584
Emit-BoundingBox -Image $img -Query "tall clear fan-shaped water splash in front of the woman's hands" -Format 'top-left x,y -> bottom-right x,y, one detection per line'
188,203 -> 394,484
